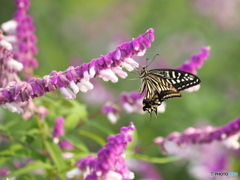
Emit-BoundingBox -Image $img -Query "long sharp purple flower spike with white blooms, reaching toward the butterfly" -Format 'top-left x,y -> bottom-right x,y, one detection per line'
0,29 -> 154,113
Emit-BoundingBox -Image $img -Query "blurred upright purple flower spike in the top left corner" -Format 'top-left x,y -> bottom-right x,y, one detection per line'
2,0 -> 38,71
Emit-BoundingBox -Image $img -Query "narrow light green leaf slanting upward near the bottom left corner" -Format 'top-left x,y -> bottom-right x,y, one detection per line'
7,161 -> 53,177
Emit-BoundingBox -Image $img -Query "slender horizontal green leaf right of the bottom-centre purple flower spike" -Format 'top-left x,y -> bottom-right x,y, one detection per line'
133,154 -> 181,164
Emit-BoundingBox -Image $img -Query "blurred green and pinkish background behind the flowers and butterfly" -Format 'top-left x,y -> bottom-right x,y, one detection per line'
0,0 -> 240,180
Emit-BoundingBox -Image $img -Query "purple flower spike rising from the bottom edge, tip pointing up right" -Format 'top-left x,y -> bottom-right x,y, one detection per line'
77,123 -> 135,180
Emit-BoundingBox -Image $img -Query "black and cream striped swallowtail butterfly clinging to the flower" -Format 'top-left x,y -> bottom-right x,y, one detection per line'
139,67 -> 201,117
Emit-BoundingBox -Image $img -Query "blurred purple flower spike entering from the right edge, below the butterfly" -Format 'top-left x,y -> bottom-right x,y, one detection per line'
154,117 -> 240,152
